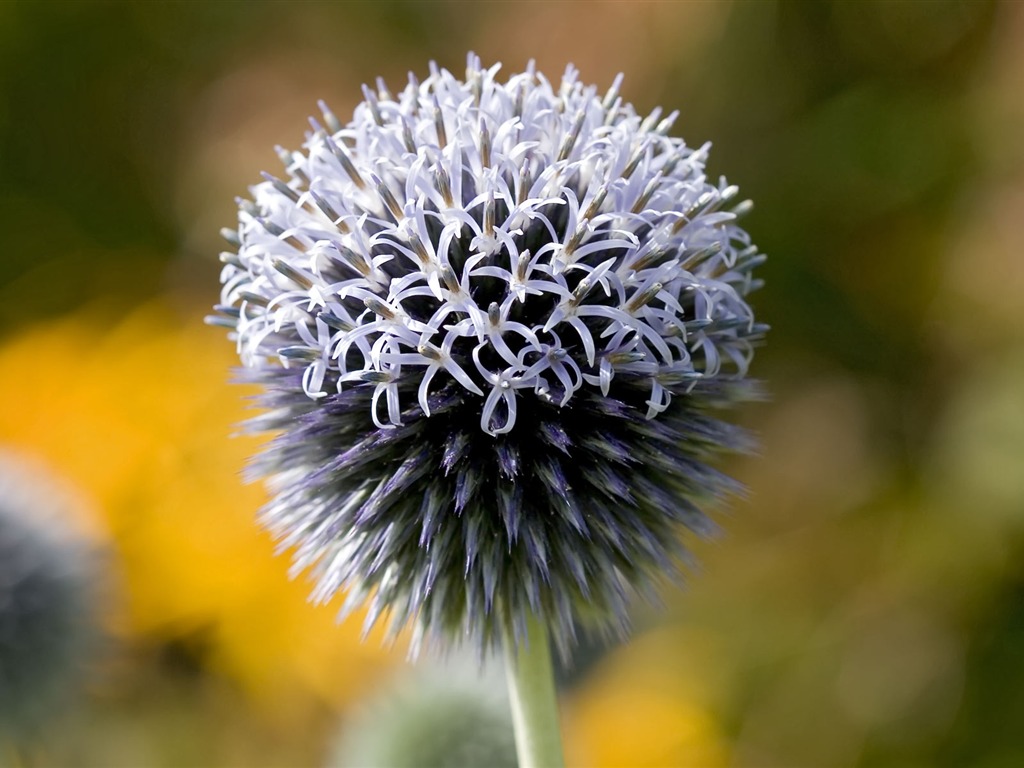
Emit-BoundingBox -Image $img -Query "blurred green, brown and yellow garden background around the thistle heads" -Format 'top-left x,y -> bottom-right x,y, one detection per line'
0,0 -> 1024,768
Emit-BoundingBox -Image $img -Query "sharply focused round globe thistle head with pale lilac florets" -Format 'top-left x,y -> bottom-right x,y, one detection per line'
211,54 -> 765,650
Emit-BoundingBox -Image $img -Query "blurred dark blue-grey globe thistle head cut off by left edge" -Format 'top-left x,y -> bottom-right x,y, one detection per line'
0,451 -> 99,744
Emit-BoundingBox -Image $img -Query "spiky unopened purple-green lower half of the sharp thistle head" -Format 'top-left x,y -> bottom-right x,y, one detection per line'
247,370 -> 749,651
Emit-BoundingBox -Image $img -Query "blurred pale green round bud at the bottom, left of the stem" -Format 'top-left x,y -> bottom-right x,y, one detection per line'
329,664 -> 516,768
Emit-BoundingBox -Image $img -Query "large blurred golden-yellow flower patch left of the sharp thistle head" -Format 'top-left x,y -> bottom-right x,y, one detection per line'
0,304 -> 388,703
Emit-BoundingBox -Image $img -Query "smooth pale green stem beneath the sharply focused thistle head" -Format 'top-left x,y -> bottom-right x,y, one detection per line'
505,616 -> 565,768
